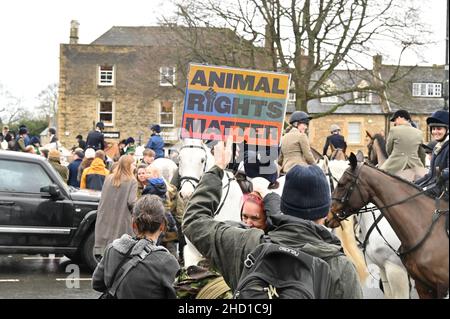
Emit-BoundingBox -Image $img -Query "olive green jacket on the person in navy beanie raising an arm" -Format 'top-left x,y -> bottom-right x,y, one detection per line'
183,166 -> 362,298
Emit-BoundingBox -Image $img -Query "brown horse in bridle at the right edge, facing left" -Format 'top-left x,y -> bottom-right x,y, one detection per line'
327,153 -> 449,298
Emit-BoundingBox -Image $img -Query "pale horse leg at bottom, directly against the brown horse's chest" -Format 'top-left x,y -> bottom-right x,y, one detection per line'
384,261 -> 409,299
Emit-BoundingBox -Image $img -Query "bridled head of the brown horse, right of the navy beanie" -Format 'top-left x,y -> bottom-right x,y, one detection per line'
325,153 -> 370,228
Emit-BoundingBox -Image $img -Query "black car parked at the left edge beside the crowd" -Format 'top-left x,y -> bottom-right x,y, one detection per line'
0,151 -> 100,270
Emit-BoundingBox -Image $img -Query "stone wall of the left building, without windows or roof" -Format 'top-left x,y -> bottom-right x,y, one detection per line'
58,44 -> 183,147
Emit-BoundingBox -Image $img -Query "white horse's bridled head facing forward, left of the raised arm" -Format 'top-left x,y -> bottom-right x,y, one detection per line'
178,138 -> 215,198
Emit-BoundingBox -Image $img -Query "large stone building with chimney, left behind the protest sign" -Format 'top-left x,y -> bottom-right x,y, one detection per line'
58,21 -> 268,147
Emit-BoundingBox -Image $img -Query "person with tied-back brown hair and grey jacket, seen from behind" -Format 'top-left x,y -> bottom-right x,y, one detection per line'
92,195 -> 180,299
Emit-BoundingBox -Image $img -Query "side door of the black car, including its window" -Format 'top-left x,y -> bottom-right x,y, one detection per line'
0,159 -> 73,247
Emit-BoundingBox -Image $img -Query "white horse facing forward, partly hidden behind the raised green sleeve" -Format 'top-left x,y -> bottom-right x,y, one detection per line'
178,138 -> 242,267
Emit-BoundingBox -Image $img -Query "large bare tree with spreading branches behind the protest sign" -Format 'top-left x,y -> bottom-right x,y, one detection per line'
163,0 -> 427,114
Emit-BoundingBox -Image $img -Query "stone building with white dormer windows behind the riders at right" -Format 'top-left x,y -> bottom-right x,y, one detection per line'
287,56 -> 444,154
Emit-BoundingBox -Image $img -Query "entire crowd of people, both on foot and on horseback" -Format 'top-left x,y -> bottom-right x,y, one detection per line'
1,110 -> 449,298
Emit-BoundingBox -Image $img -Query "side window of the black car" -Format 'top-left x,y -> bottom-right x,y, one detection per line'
0,160 -> 53,193
